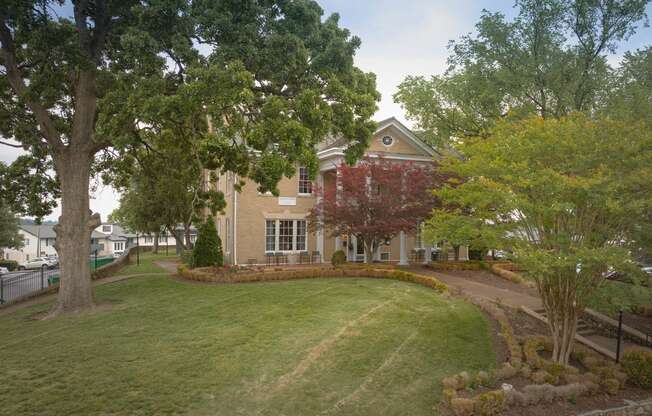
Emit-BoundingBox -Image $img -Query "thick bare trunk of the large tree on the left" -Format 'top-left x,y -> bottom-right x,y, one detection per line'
51,151 -> 101,315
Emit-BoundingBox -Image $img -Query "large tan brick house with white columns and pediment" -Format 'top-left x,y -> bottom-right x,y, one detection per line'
212,118 -> 468,264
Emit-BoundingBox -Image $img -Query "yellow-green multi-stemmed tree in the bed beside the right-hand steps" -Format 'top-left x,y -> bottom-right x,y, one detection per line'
427,114 -> 652,364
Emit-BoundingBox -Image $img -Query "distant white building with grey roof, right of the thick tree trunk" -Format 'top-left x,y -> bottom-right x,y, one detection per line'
93,223 -> 197,257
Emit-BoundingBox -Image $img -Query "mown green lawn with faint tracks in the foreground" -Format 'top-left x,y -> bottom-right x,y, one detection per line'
0,265 -> 495,416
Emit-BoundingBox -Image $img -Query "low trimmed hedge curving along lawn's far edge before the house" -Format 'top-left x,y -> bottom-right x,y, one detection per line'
177,264 -> 448,293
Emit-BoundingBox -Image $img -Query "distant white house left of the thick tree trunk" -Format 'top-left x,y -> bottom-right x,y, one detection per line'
3,224 -> 104,263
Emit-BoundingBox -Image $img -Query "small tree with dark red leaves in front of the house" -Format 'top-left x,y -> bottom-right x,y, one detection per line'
308,159 -> 439,263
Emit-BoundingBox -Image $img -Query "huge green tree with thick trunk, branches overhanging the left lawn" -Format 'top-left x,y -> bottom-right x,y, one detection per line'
0,0 -> 379,315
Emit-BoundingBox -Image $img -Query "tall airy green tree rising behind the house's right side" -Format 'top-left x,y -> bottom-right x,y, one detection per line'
394,0 -> 648,144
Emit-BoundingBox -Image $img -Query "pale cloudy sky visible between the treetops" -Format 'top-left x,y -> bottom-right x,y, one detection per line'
0,0 -> 652,221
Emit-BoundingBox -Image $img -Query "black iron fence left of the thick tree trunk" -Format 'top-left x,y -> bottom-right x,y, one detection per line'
0,267 -> 59,304
